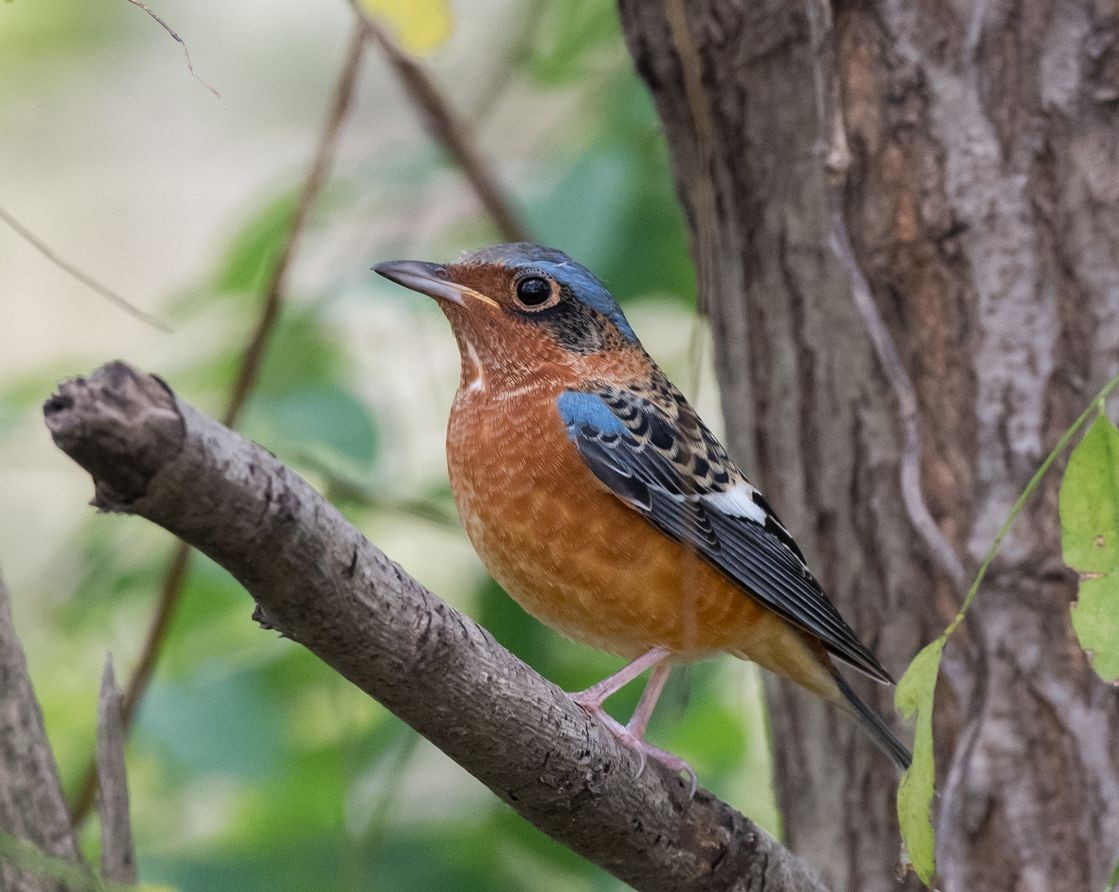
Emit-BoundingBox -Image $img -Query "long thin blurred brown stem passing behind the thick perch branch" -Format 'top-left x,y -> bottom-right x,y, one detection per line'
67,15 -> 365,824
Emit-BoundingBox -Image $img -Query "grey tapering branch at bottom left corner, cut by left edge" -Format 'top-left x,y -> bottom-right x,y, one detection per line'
0,566 -> 87,892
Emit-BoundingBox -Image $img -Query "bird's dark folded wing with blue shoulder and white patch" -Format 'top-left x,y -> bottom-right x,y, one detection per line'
556,378 -> 893,683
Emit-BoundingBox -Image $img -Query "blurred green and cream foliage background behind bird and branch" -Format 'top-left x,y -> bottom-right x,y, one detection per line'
0,0 -> 779,890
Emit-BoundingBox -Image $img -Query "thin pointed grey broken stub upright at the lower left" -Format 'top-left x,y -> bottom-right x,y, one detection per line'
97,655 -> 137,885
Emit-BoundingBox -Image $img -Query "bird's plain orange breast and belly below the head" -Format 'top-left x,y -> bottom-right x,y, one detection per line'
448,381 -> 787,665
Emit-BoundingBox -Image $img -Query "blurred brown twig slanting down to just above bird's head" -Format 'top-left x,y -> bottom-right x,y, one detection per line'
350,13 -> 529,242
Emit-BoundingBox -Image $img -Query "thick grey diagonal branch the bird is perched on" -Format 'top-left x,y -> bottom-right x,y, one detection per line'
44,363 -> 822,892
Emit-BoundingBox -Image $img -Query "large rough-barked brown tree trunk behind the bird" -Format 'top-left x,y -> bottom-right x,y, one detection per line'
621,0 -> 1119,892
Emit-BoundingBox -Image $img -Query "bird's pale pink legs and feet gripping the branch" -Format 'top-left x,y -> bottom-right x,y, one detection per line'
571,647 -> 697,796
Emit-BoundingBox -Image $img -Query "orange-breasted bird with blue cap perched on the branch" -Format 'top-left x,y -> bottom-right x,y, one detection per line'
373,243 -> 911,795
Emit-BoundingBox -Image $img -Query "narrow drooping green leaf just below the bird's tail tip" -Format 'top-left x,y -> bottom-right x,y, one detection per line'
894,636 -> 948,885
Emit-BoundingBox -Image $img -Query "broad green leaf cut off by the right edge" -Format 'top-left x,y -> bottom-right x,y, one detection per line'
1060,415 -> 1119,682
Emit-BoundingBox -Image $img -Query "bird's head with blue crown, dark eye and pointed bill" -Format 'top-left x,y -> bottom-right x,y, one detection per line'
373,243 -> 640,382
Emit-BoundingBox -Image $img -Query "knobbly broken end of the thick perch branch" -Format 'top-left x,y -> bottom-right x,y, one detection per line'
43,360 -> 186,511
